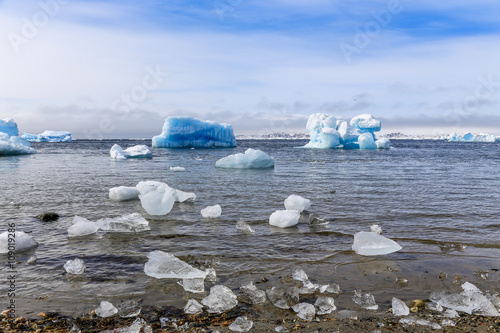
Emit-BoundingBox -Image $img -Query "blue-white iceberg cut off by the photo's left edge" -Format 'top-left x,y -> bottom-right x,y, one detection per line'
0,119 -> 35,155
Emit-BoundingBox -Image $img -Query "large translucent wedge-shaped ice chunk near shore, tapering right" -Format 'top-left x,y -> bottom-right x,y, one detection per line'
144,251 -> 207,279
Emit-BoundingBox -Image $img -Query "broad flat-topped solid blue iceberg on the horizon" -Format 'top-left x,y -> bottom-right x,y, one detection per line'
153,117 -> 236,148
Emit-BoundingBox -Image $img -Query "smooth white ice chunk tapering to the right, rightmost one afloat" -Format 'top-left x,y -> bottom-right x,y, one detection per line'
352,231 -> 402,256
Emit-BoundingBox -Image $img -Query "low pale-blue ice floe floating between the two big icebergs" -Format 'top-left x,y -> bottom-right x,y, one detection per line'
215,148 -> 274,169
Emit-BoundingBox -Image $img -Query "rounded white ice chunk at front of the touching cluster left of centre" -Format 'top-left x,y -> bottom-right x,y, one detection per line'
138,183 -> 177,215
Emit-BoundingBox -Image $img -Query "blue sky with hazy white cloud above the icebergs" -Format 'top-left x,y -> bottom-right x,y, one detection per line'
0,0 -> 500,139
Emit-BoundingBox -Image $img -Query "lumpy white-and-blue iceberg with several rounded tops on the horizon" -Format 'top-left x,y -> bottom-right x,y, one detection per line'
305,113 -> 390,149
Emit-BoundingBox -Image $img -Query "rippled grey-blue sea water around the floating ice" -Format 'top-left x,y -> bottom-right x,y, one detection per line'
0,140 -> 500,316
